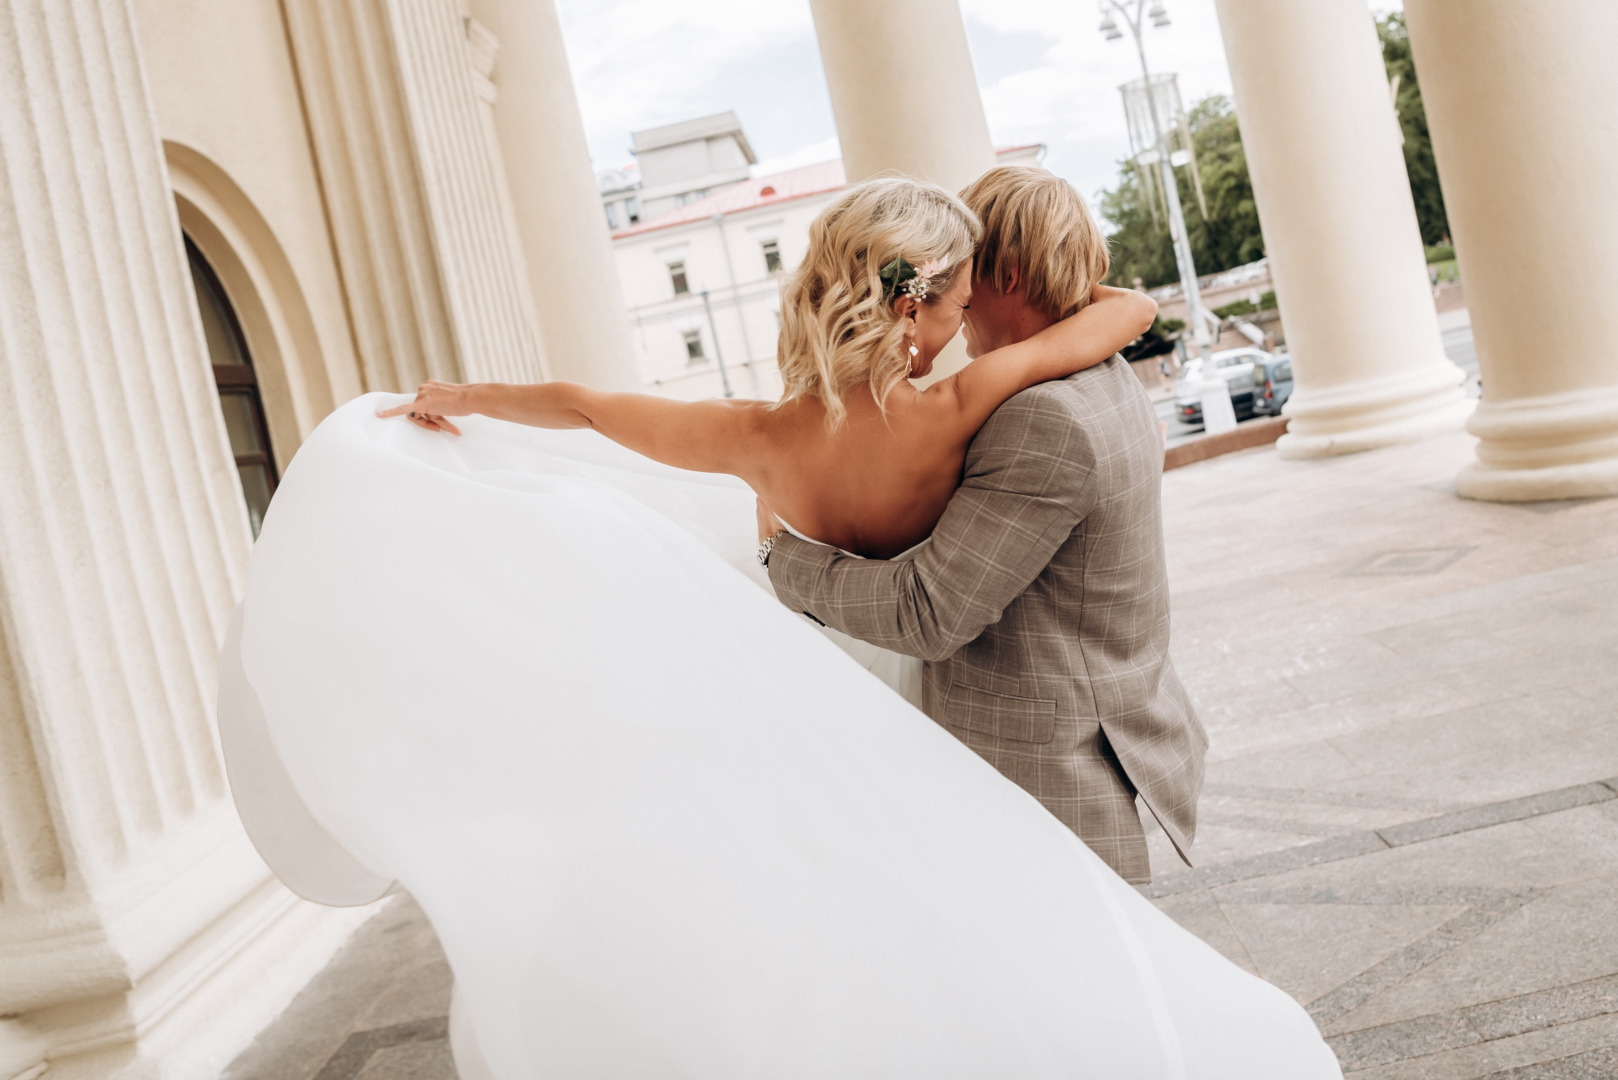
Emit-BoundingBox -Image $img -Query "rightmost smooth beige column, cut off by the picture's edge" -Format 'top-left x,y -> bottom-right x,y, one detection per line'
1406,0 -> 1618,502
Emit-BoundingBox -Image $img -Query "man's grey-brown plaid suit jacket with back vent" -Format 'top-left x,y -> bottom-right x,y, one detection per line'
770,356 -> 1207,882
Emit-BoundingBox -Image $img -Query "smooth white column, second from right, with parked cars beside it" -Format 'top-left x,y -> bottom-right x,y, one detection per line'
1217,0 -> 1471,457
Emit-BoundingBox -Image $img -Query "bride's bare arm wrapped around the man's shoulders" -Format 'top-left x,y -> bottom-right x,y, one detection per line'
940,285 -> 1157,432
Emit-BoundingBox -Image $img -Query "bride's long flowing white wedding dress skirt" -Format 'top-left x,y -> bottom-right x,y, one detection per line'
220,395 -> 1340,1080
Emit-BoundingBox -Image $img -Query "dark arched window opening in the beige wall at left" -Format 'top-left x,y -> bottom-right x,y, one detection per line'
186,236 -> 277,536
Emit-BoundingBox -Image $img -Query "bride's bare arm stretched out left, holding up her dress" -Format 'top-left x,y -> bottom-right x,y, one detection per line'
377,381 -> 767,479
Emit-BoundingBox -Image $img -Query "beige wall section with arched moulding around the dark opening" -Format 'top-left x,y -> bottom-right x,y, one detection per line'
134,0 -> 366,468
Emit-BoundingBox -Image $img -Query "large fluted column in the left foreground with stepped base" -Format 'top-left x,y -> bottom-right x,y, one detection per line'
0,0 -> 367,1078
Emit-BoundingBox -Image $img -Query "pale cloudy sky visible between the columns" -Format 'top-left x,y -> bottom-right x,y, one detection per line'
557,0 -> 1403,208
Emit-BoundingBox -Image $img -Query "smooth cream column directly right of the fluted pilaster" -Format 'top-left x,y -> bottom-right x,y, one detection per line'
469,0 -> 641,390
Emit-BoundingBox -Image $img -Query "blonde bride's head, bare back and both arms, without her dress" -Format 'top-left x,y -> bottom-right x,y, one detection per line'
379,176 -> 1157,559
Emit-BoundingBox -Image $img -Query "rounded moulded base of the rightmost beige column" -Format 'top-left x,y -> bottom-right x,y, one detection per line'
1455,387 -> 1618,502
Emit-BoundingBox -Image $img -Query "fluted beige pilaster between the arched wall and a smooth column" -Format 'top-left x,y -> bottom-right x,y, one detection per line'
283,0 -> 544,390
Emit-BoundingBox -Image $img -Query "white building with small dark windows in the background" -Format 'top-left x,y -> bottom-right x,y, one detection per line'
608,141 -> 1045,400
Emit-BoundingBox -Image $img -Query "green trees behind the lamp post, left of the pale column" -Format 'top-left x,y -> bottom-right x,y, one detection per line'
1097,94 -> 1264,288
